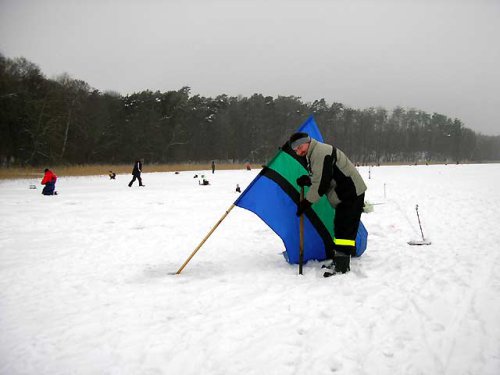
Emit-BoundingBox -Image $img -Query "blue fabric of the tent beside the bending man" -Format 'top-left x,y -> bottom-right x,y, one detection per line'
234,116 -> 368,264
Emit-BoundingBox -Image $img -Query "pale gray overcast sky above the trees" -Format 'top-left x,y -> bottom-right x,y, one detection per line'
0,0 -> 500,135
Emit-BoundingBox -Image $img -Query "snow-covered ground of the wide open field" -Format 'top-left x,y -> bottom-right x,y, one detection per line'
0,164 -> 500,375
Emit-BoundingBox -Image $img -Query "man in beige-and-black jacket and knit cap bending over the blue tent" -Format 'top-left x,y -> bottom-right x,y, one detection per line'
290,133 -> 366,277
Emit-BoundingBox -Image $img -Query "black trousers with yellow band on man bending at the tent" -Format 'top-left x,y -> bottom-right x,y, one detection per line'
333,193 -> 365,256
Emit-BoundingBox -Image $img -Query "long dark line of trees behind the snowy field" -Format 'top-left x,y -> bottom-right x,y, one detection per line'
0,55 -> 500,166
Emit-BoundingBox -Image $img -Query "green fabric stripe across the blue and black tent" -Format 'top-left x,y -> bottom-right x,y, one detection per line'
267,151 -> 335,238
